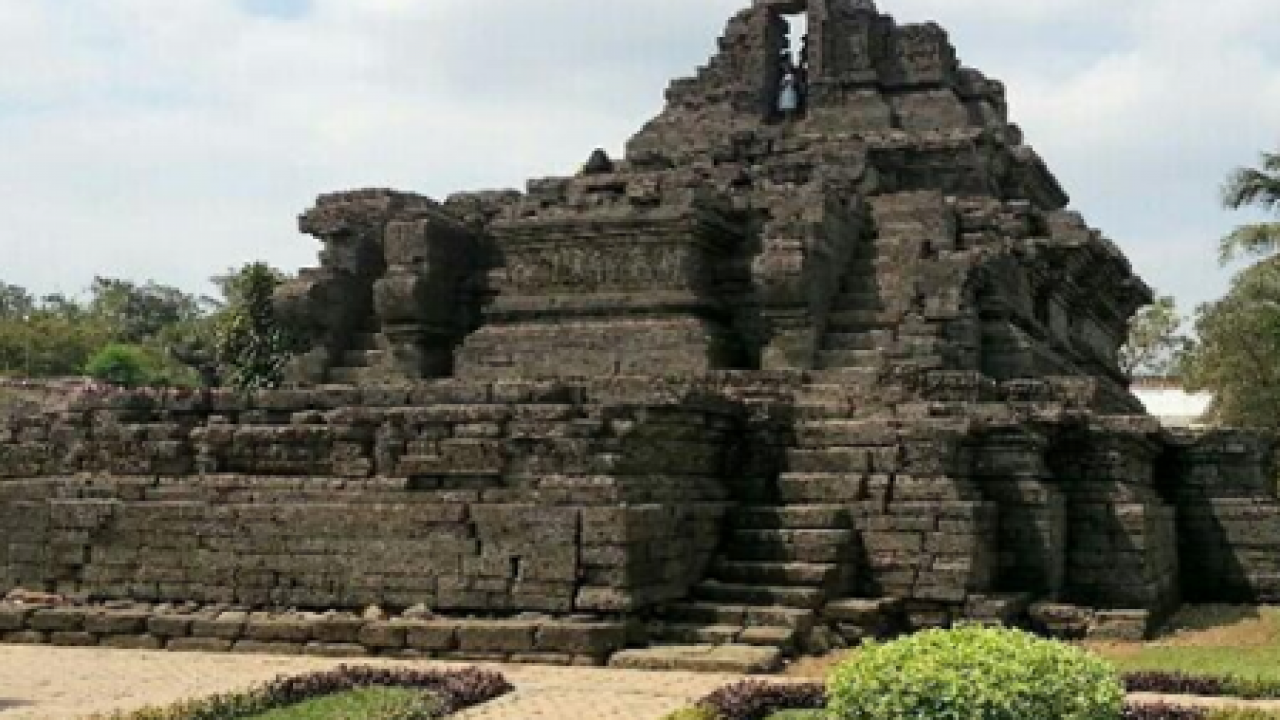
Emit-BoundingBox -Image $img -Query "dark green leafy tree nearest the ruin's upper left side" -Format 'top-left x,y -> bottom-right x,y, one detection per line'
215,263 -> 298,391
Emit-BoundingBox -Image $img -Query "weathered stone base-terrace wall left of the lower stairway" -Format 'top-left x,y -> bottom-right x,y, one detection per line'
0,383 -> 735,612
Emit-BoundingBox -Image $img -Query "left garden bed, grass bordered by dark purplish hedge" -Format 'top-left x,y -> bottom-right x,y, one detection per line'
97,666 -> 512,720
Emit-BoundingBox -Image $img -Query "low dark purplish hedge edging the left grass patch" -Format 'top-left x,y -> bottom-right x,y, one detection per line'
96,665 -> 513,720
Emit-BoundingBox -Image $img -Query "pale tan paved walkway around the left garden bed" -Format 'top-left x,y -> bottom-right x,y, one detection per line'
0,646 -> 737,720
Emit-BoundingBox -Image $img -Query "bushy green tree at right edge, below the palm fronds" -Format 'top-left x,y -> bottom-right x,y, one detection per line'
1183,259 -> 1280,429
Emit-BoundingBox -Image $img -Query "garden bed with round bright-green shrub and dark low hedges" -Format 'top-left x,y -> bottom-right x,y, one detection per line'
664,628 -> 1280,720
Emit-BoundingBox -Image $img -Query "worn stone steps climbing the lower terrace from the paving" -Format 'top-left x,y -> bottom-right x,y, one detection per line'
611,386 -> 861,673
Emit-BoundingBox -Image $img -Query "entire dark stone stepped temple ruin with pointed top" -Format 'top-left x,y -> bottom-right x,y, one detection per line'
0,0 -> 1280,670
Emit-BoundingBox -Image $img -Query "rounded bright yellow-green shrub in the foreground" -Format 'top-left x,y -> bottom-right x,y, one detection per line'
829,628 -> 1124,720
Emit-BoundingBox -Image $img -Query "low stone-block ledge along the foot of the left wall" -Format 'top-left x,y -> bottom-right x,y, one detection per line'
0,603 -> 628,666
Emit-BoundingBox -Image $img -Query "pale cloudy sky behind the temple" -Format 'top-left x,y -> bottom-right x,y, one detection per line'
0,0 -> 1280,310
